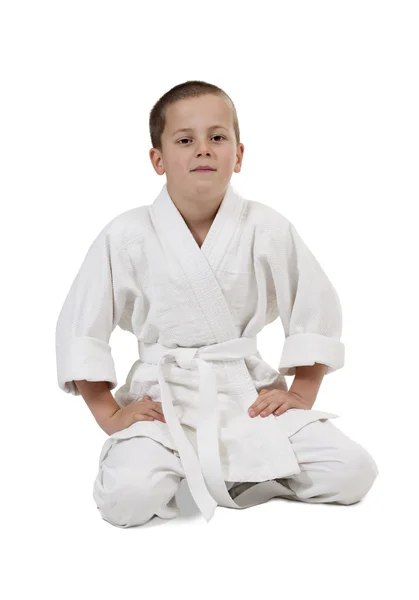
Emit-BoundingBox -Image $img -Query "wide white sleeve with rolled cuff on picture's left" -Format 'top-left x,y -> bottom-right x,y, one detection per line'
55,226 -> 132,396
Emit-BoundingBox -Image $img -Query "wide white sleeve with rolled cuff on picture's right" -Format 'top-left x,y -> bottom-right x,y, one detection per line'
274,222 -> 345,375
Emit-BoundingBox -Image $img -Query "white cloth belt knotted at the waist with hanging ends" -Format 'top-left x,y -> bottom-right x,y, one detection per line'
138,337 -> 257,522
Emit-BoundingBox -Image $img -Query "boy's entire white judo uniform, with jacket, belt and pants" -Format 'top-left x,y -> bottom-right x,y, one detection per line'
56,183 -> 378,527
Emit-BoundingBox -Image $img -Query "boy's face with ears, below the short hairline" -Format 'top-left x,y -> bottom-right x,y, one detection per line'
150,94 -> 244,198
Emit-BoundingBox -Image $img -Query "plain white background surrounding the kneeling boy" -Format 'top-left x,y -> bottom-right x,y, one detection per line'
0,0 -> 419,600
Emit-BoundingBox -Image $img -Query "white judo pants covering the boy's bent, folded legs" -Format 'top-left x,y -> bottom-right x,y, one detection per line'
93,420 -> 379,527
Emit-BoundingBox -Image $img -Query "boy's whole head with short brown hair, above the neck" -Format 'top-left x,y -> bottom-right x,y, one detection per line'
149,81 -> 244,202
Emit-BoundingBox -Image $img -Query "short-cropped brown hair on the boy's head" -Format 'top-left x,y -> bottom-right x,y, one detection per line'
149,80 -> 240,152
